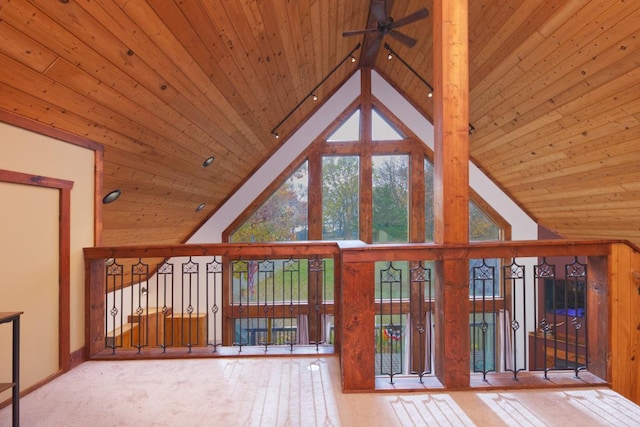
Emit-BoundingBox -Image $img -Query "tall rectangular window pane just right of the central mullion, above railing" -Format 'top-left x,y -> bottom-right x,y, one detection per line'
372,155 -> 409,243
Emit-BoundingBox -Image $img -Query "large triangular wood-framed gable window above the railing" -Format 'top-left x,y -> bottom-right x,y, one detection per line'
229,107 -> 503,247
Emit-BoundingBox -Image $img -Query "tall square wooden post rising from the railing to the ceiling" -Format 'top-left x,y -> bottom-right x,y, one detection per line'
433,0 -> 470,389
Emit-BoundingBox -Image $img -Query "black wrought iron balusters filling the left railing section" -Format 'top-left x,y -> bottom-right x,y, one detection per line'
105,256 -> 333,353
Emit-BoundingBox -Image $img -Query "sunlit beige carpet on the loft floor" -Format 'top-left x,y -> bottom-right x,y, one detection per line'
0,356 -> 640,427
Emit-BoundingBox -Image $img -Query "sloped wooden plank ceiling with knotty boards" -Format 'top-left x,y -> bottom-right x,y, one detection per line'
0,0 -> 640,245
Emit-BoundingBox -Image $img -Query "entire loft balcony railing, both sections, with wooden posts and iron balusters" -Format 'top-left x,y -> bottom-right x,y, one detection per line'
85,240 -> 640,402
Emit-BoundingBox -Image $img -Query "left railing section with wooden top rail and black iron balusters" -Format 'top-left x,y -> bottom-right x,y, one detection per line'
85,242 -> 340,359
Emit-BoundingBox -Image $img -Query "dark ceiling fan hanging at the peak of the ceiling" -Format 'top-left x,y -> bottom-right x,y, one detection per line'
342,0 -> 429,67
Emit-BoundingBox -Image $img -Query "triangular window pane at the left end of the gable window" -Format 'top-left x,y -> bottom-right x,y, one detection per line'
231,162 -> 308,243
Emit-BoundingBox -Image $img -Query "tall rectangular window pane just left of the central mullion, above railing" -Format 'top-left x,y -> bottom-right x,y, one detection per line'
322,156 -> 360,240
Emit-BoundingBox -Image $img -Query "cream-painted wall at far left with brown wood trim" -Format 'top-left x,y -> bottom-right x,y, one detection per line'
0,123 -> 95,394
